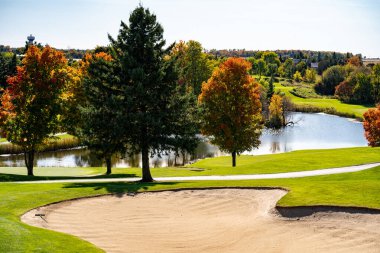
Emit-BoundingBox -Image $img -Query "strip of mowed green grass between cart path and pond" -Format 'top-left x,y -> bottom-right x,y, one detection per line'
0,147 -> 380,181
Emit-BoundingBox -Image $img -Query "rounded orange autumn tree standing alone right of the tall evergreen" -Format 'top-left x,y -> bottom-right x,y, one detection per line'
198,58 -> 263,167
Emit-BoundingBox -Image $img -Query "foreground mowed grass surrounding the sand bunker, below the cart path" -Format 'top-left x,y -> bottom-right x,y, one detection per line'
0,167 -> 380,252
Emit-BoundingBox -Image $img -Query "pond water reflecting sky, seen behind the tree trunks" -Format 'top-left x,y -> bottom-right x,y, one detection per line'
0,113 -> 367,167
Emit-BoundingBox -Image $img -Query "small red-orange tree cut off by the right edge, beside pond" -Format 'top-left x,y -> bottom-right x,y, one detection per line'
363,104 -> 380,147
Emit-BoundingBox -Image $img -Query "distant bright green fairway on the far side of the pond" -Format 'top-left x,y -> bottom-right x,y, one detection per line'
275,83 -> 372,119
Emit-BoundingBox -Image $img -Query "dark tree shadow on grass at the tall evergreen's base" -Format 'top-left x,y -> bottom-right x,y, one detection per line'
63,181 -> 178,197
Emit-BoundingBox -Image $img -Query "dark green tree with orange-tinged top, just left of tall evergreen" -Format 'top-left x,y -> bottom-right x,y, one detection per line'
76,53 -> 125,175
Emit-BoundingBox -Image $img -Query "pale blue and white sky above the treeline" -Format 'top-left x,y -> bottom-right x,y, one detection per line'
0,0 -> 380,57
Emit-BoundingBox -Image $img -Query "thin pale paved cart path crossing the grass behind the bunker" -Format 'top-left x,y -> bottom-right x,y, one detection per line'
8,163 -> 380,184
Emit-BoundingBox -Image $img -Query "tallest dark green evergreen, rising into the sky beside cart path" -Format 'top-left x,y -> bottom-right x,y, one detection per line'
109,6 -> 190,182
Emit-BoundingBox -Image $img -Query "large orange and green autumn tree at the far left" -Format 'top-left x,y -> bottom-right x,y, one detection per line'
0,46 -> 67,176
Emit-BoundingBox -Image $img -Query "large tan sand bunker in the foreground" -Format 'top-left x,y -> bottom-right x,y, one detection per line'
22,189 -> 380,253
